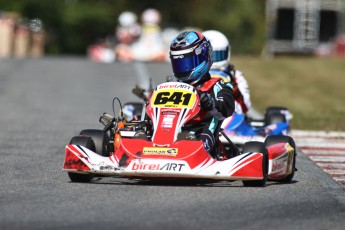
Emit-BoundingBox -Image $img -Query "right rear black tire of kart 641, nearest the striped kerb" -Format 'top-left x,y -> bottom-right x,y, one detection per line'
265,135 -> 297,183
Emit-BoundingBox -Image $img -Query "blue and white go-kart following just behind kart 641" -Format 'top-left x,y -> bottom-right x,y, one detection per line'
220,106 -> 292,147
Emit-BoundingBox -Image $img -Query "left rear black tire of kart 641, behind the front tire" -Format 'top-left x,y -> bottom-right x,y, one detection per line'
80,129 -> 109,157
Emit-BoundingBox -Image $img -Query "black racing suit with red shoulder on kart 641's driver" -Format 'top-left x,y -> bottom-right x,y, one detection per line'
187,74 -> 235,155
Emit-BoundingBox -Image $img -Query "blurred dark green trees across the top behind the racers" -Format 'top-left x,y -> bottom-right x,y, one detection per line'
0,0 -> 265,54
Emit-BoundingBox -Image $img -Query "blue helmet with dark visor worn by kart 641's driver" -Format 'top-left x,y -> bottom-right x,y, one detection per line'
170,31 -> 213,85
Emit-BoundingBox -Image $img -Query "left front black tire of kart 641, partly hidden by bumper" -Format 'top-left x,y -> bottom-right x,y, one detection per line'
68,136 -> 95,183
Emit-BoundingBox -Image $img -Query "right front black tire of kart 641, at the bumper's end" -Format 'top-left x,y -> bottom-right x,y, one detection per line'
242,141 -> 268,187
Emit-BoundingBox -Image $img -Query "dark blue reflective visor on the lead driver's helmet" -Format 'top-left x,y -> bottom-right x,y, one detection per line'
170,52 -> 207,75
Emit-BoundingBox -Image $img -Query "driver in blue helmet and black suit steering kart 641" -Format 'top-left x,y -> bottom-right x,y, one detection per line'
170,31 -> 235,155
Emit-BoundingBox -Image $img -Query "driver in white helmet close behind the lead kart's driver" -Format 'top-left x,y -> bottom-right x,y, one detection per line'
203,30 -> 251,116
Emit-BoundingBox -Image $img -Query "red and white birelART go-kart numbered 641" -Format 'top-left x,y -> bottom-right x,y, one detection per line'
63,82 -> 296,186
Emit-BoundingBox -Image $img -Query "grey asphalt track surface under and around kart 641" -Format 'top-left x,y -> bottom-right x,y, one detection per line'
0,57 -> 345,230
